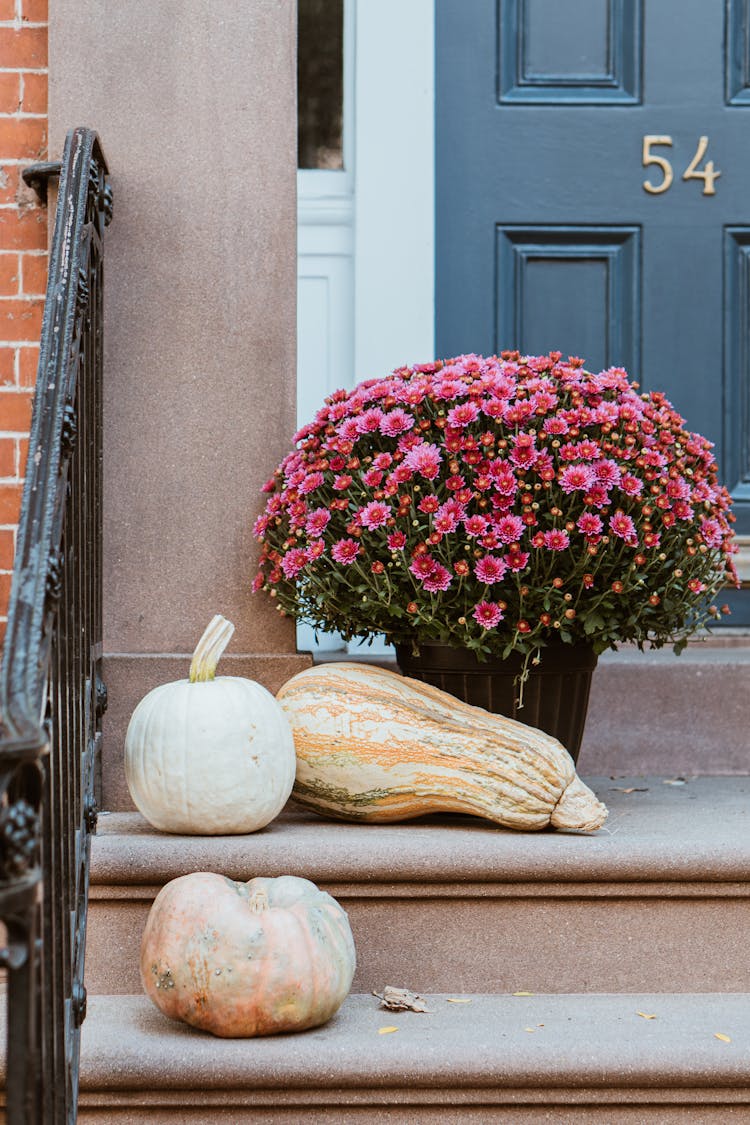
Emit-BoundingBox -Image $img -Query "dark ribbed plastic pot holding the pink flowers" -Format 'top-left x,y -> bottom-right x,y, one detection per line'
396,644 -> 597,761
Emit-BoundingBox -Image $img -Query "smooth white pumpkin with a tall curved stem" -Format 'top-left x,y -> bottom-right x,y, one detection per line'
125,614 -> 296,836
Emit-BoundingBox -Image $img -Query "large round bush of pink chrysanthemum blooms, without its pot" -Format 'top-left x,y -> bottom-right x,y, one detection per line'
253,352 -> 737,659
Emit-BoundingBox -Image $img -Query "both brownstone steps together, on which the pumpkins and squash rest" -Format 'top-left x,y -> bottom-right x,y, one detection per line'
79,777 -> 750,1125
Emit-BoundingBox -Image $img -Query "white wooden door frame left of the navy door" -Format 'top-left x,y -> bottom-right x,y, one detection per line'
297,0 -> 435,653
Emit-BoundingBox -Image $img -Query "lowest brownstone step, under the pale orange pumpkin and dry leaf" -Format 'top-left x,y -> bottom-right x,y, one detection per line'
78,990 -> 750,1125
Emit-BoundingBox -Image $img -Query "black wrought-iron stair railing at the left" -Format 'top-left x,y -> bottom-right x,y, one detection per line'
0,128 -> 111,1125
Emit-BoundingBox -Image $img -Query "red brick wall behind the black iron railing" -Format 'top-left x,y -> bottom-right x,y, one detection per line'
0,0 -> 47,642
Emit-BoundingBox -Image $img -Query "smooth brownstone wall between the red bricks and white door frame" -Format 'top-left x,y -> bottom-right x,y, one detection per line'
49,0 -> 302,799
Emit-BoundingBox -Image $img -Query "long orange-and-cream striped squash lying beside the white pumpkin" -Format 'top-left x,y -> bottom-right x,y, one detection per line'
277,664 -> 607,830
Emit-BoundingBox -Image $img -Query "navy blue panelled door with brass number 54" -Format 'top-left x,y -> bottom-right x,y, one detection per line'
436,0 -> 750,571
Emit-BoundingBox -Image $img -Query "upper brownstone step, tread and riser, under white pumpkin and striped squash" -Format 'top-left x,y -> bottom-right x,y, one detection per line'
87,777 -> 750,999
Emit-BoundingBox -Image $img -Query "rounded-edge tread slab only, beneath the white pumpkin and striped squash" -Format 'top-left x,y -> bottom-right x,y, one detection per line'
92,777 -> 750,884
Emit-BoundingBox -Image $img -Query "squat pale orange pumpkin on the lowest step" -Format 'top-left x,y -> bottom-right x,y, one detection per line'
141,872 -> 355,1037
